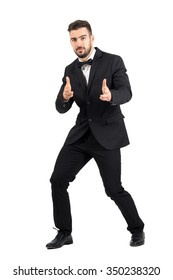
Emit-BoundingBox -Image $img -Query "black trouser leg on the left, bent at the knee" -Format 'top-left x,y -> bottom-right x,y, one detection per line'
50,145 -> 91,235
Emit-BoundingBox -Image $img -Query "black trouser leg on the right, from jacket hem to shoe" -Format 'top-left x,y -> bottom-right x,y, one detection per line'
94,149 -> 144,234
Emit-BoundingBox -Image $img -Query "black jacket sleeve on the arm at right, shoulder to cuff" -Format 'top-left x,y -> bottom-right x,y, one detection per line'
110,56 -> 132,106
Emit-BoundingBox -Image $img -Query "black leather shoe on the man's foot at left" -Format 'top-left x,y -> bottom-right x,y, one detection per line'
46,231 -> 73,249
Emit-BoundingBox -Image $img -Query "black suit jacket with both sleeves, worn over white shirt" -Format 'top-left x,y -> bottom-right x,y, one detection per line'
56,48 -> 132,150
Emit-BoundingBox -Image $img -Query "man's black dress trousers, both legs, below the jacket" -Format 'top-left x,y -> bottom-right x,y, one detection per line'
50,130 -> 144,235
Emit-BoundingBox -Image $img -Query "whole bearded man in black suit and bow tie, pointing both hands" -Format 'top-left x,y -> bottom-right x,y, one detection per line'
46,20 -> 144,249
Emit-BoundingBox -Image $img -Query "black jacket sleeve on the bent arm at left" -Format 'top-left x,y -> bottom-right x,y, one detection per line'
55,74 -> 74,113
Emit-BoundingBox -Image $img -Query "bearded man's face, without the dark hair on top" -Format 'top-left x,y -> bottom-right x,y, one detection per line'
70,27 -> 94,58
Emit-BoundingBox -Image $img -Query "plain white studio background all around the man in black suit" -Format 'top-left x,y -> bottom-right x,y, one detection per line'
0,0 -> 173,280
